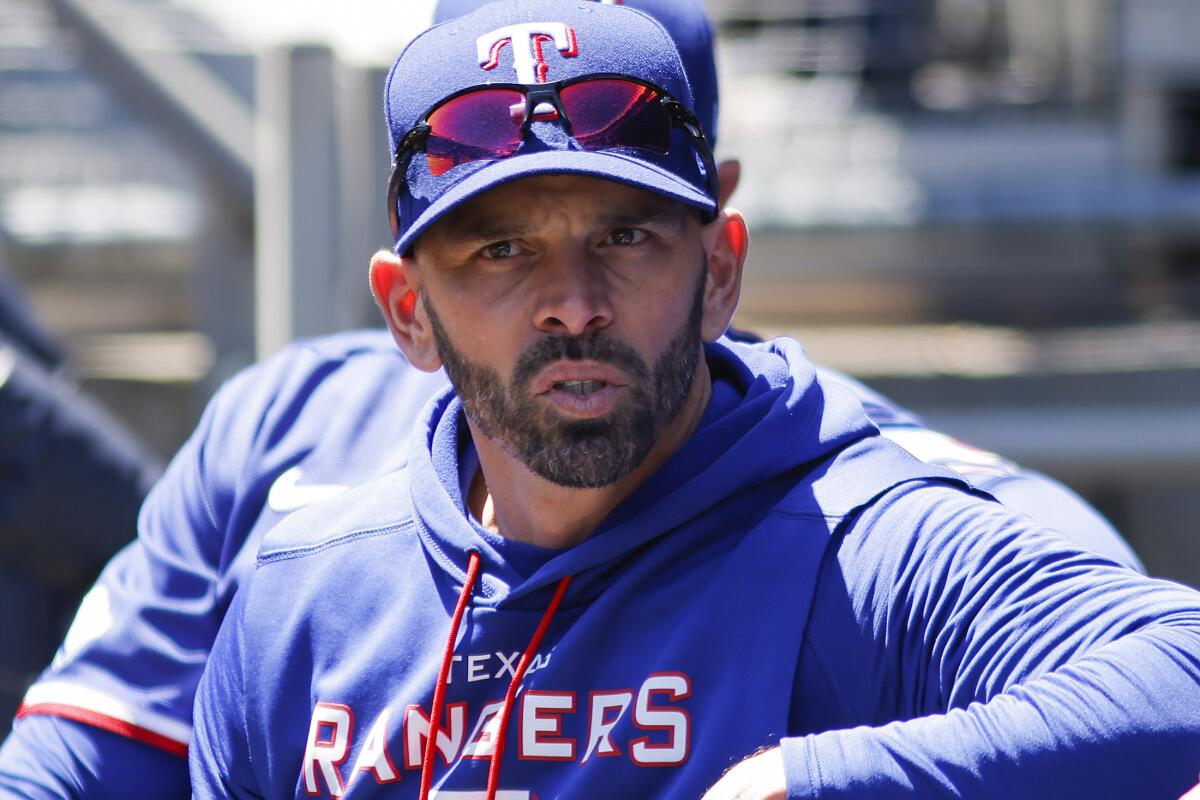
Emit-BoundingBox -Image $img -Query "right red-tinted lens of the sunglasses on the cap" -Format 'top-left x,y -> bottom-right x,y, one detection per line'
559,78 -> 671,154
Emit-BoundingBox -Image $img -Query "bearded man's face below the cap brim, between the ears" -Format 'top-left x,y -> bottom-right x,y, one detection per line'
415,176 -> 707,488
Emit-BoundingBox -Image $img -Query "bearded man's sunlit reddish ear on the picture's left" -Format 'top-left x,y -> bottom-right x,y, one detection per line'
371,249 -> 442,372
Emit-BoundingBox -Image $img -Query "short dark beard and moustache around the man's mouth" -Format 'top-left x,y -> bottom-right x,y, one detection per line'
421,259 -> 708,489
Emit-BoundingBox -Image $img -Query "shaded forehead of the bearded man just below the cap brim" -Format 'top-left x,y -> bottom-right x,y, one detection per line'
421,175 -> 698,243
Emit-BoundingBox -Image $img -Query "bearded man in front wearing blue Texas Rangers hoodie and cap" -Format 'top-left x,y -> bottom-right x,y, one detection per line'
191,0 -> 1200,799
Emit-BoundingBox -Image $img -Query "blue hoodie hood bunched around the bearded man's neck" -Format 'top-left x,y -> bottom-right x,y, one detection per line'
408,339 -> 894,606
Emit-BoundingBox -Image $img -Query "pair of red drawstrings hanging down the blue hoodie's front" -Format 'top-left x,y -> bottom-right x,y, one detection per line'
418,551 -> 571,800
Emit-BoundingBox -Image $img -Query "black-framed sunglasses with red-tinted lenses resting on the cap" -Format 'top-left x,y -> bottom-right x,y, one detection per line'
388,74 -> 718,239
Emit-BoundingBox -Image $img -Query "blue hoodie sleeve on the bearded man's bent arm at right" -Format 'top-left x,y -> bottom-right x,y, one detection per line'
782,485 -> 1200,800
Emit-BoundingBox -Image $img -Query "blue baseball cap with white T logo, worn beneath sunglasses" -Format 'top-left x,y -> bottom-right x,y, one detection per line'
384,0 -> 716,253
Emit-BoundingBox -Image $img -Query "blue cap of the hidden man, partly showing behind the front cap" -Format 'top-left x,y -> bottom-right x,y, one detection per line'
433,0 -> 720,146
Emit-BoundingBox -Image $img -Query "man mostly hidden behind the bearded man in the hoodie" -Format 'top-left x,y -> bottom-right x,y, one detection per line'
0,0 -> 1136,798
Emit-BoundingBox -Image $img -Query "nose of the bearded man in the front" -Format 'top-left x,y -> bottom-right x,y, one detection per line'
533,253 -> 613,336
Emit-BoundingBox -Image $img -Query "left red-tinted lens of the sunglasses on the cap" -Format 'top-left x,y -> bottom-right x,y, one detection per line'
425,89 -> 524,175
